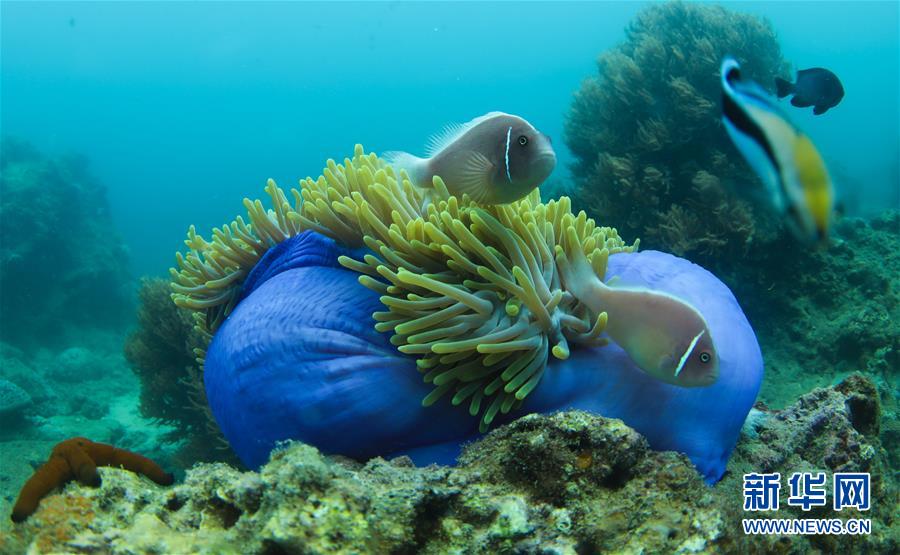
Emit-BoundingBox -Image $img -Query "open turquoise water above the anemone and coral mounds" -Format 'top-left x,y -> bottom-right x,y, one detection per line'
2,2 -> 900,275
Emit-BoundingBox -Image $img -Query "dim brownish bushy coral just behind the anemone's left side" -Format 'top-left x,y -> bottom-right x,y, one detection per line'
125,278 -> 227,467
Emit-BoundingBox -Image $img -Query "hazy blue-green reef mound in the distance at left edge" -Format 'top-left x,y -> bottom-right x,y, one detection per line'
0,138 -> 133,347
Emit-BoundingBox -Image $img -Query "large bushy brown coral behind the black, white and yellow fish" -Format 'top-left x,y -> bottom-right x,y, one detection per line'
565,2 -> 786,262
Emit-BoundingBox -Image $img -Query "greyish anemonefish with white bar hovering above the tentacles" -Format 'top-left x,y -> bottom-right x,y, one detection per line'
385,112 -> 556,204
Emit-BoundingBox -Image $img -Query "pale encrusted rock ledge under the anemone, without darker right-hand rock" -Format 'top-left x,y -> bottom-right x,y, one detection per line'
1,412 -> 721,553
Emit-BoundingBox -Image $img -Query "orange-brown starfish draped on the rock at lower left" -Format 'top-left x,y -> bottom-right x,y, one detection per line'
12,437 -> 175,522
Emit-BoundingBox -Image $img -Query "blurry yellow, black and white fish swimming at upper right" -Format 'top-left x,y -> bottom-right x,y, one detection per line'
721,58 -> 834,241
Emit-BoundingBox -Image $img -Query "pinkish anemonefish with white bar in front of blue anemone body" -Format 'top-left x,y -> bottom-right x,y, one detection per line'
556,238 -> 719,387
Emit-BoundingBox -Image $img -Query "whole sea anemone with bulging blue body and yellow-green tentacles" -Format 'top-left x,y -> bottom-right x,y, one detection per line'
172,146 -> 762,481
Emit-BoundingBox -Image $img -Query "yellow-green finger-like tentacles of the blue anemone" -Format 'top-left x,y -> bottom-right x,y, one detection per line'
170,145 -> 638,431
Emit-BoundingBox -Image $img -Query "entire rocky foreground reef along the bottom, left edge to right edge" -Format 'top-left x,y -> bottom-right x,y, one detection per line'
0,376 -> 900,553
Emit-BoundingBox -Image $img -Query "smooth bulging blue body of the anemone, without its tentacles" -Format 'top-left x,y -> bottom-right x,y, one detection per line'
204,232 -> 763,482
